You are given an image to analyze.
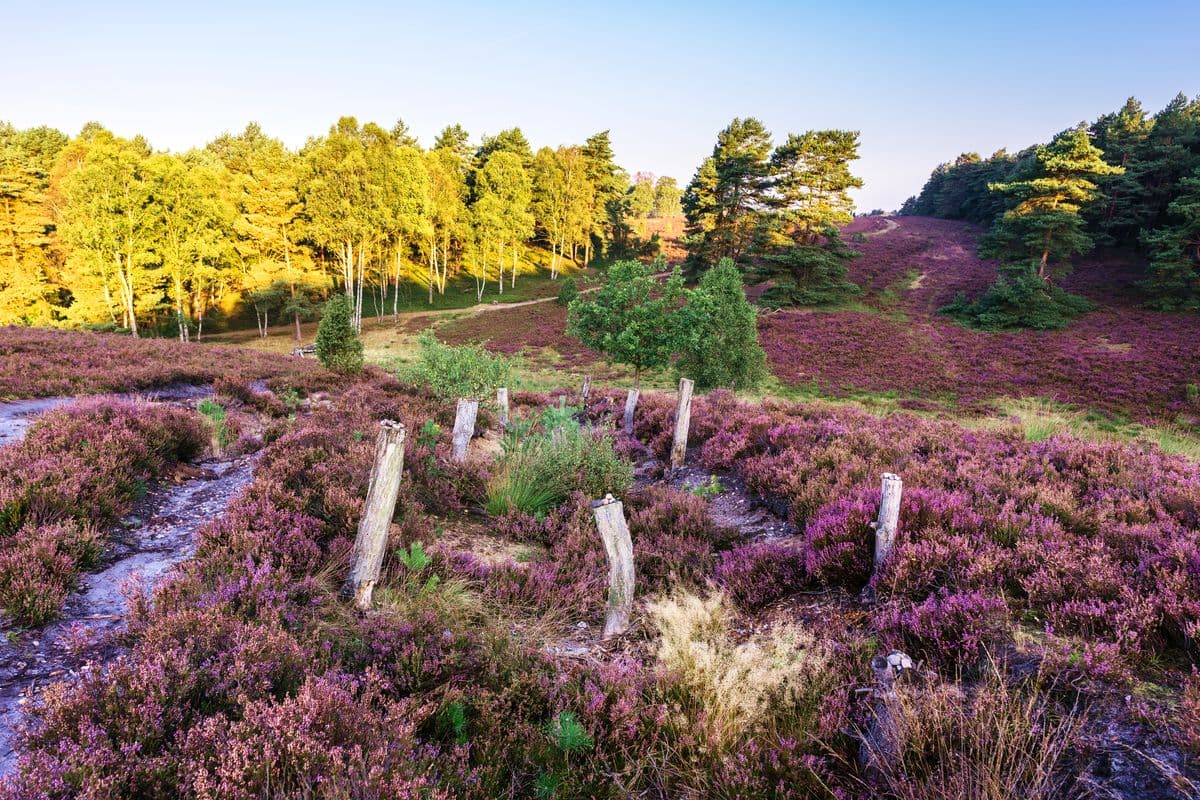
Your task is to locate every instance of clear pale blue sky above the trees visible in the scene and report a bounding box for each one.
[0,0,1200,210]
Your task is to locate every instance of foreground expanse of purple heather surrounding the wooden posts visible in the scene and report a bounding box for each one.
[0,331,1200,800]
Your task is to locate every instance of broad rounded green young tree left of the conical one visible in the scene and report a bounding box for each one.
[566,261,684,380]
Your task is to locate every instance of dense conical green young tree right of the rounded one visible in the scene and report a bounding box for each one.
[676,258,767,389]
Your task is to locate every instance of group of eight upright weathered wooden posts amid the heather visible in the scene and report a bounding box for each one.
[342,378,904,638]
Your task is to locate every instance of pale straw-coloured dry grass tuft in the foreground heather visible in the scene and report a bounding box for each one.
[646,593,829,756]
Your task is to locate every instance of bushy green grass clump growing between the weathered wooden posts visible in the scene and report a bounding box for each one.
[487,409,634,516]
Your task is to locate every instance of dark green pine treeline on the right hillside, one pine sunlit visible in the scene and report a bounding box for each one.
[900,94,1200,326]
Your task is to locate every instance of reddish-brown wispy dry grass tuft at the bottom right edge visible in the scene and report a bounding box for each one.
[864,663,1084,800]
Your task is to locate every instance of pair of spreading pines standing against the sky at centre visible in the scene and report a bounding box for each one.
[683,118,863,306]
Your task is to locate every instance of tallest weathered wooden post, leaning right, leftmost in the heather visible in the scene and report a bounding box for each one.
[342,420,406,610]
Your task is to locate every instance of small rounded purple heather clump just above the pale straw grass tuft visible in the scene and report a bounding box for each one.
[716,540,805,610]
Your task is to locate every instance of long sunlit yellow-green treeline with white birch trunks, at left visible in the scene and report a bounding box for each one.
[0,118,680,341]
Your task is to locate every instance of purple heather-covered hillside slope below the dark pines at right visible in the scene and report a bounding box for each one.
[761,217,1200,421]
